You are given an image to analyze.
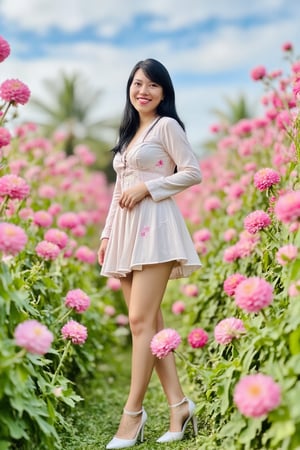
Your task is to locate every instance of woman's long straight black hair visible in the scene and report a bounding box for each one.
[112,58,185,153]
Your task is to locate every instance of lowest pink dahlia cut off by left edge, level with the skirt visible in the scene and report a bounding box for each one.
[0,222,28,255]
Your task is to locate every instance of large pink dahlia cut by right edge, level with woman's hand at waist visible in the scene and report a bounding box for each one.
[274,190,300,223]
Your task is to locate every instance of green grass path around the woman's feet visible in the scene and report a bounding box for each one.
[57,351,206,450]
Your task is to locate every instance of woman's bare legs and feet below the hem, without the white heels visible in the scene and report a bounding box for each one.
[117,264,188,439]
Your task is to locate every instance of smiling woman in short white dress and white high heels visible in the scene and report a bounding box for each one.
[98,59,201,449]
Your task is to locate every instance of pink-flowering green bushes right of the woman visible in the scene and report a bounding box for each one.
[169,44,300,450]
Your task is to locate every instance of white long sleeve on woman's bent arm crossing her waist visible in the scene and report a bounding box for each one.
[145,118,201,202]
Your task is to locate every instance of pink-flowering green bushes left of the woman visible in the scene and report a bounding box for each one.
[0,37,123,450]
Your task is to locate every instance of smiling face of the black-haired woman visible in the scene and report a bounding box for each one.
[129,69,163,118]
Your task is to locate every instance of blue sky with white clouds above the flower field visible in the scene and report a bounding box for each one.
[0,0,300,147]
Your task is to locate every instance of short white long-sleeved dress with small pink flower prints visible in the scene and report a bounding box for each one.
[101,117,201,278]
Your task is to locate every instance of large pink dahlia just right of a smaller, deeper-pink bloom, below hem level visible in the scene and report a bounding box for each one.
[235,277,273,312]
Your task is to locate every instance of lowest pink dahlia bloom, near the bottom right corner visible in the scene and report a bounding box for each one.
[233,373,281,417]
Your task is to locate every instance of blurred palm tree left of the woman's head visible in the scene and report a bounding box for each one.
[30,73,117,165]
